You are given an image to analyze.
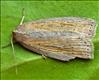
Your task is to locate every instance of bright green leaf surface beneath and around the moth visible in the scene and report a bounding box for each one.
[1,1,99,80]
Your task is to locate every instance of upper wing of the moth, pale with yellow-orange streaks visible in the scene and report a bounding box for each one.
[17,17,96,38]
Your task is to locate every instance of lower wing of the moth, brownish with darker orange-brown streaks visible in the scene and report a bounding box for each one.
[14,32,93,61]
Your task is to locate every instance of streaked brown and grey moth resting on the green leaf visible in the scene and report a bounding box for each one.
[13,17,96,61]
